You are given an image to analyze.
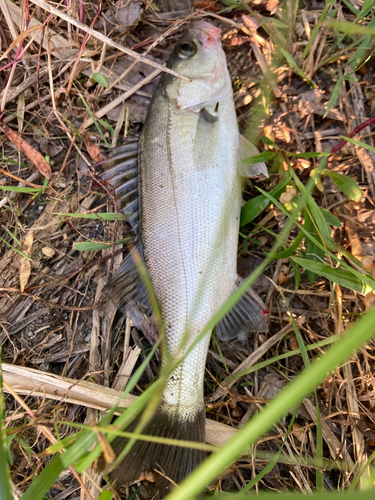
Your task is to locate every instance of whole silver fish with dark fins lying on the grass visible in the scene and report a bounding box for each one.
[98,21,268,498]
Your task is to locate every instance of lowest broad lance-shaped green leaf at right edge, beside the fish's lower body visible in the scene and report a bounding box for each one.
[291,257,375,294]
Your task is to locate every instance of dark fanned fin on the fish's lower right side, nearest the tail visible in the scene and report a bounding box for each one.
[216,278,268,340]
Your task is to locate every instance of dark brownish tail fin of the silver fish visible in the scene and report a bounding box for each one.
[110,407,205,498]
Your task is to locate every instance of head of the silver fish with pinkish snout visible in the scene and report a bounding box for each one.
[166,21,232,111]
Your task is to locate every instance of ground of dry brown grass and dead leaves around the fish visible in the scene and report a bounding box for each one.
[0,0,375,500]
